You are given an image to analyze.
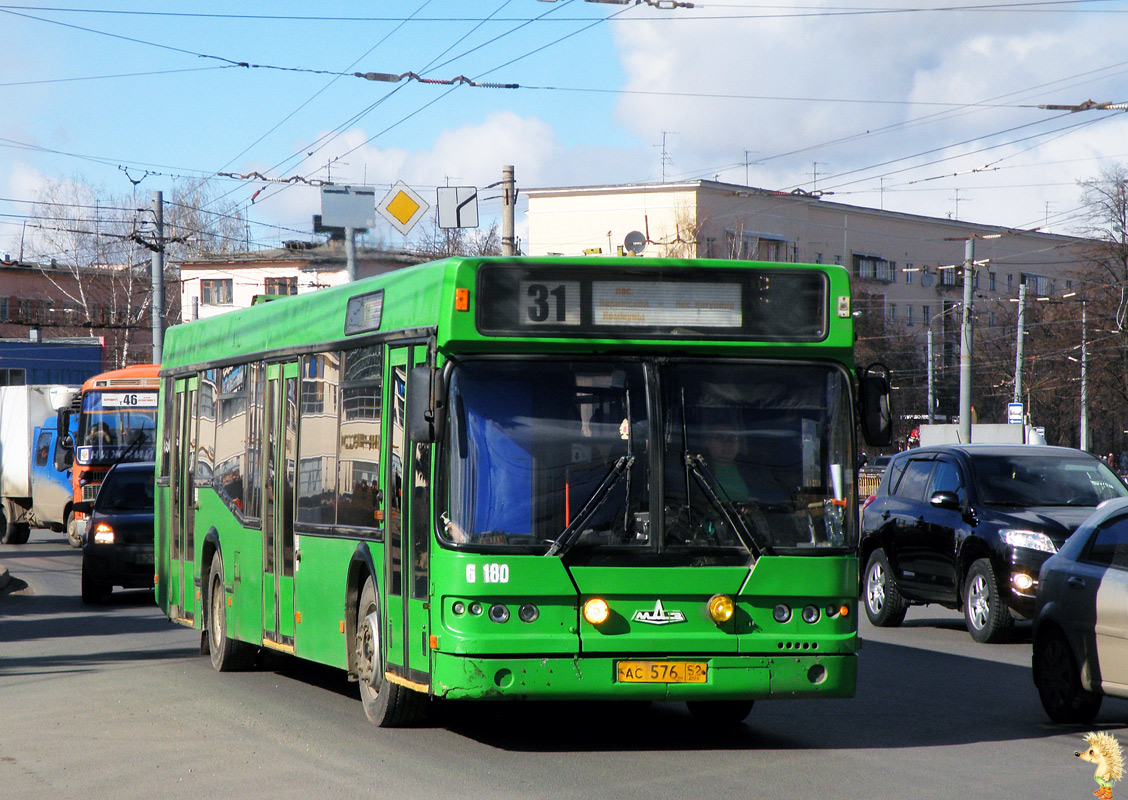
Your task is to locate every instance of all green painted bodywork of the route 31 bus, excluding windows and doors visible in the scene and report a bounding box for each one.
[156,257,857,700]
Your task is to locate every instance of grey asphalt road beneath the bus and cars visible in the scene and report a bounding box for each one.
[0,530,1128,800]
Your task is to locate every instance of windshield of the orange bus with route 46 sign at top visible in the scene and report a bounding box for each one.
[76,390,157,464]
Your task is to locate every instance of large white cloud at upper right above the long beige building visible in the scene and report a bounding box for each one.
[616,3,1128,232]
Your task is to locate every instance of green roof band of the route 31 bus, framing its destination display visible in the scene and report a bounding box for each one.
[161,256,854,375]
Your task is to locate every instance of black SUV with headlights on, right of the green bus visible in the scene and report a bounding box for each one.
[858,445,1128,642]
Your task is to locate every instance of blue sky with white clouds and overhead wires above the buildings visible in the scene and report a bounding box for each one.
[0,0,1128,256]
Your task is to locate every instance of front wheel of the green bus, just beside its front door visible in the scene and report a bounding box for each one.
[353,578,426,728]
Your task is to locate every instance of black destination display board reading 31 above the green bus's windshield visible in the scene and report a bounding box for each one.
[477,265,828,342]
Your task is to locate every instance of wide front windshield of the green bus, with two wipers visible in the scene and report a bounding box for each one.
[440,359,856,557]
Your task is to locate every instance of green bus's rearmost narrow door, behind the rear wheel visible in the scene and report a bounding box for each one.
[169,376,199,622]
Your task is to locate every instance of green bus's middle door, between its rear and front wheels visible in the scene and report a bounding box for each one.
[263,362,298,652]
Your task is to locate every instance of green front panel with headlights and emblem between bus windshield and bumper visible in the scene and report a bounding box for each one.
[432,554,857,657]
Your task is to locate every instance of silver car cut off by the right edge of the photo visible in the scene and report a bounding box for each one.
[1032,498,1128,723]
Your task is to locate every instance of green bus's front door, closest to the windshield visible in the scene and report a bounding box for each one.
[381,345,431,688]
